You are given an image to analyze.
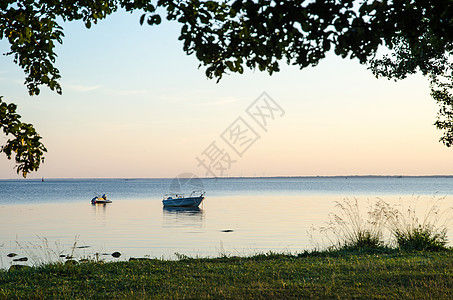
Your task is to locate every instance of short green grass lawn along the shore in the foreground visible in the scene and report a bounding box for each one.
[0,250,453,299]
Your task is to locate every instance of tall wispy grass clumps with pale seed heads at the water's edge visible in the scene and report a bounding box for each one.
[320,197,453,251]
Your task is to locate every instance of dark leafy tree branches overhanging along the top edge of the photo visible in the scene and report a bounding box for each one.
[0,0,453,176]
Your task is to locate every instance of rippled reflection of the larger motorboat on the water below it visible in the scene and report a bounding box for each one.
[162,207,204,229]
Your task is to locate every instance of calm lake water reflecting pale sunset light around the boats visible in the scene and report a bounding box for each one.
[0,177,453,267]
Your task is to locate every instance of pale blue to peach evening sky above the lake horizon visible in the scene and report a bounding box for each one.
[0,12,453,179]
